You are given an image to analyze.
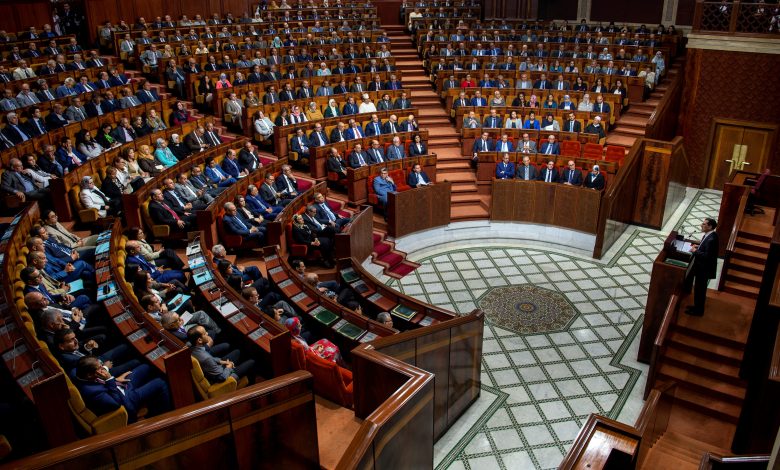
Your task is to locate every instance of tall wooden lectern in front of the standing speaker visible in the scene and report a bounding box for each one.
[637,231,693,364]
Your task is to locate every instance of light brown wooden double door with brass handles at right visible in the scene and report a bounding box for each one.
[707,120,777,189]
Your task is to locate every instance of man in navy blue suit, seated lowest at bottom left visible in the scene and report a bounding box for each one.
[74,356,171,423]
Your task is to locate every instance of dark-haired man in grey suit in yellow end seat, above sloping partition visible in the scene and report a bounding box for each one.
[187,325,255,384]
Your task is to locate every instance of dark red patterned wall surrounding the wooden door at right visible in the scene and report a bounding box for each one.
[680,49,780,186]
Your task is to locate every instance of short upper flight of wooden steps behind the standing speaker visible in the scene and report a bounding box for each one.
[723,230,771,299]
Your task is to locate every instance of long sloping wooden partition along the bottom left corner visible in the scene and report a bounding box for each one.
[2,371,319,470]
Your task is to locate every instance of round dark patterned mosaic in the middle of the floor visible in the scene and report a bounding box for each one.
[478,284,577,334]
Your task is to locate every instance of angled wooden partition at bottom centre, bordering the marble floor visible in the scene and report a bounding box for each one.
[337,310,484,469]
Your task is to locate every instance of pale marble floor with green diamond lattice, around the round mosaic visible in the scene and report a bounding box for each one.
[366,189,720,470]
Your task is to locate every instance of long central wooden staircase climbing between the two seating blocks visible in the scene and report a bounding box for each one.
[382,25,490,221]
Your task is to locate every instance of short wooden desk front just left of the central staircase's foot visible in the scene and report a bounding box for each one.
[386,181,452,237]
